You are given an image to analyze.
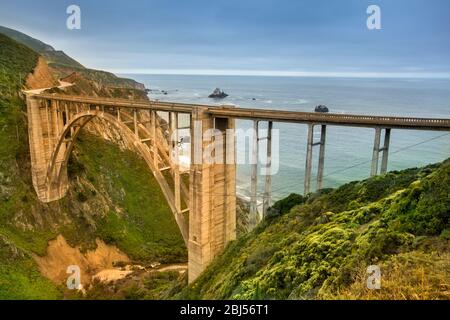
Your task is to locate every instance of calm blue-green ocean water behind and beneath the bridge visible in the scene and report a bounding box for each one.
[123,74,450,200]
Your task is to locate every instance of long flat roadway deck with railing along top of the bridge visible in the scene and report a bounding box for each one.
[32,94,450,131]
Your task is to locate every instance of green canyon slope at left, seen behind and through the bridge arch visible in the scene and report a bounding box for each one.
[0,34,187,299]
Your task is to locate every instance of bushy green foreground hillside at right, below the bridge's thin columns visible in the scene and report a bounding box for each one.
[181,159,450,299]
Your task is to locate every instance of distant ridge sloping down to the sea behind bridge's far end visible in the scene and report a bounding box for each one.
[0,26,145,91]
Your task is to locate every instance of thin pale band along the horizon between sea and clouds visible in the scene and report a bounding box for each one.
[109,68,450,79]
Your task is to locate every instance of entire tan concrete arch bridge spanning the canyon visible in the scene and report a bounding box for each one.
[27,93,450,281]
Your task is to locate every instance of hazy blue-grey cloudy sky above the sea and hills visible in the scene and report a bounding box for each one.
[0,0,450,76]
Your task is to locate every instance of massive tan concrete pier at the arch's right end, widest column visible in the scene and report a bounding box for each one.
[188,107,236,282]
